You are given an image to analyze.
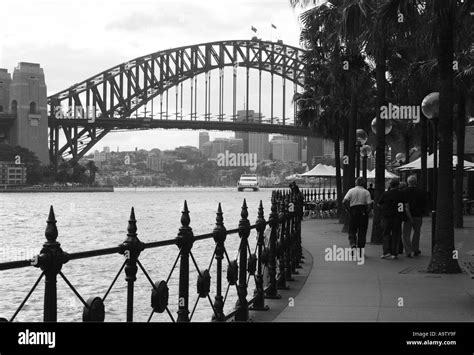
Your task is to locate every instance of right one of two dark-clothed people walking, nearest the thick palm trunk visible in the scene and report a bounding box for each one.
[403,175,428,258]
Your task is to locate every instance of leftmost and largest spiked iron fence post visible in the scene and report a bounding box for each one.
[31,206,69,322]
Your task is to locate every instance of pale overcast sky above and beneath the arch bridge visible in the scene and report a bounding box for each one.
[0,0,310,151]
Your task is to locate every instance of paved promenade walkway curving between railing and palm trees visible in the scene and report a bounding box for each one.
[269,216,474,322]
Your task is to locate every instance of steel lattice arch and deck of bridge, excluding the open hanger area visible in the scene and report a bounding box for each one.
[48,40,311,163]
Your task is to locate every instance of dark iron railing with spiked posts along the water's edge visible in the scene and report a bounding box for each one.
[0,191,303,322]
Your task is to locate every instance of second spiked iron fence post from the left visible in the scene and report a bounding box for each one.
[119,207,144,322]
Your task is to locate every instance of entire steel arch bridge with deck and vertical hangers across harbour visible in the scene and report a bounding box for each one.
[4,38,312,164]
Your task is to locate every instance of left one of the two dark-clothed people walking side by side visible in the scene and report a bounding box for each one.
[378,179,411,259]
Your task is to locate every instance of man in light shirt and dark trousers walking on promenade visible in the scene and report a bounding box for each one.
[343,177,372,251]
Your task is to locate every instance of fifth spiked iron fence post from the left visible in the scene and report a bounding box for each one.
[235,199,250,322]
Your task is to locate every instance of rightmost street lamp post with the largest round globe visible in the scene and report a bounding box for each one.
[421,92,439,253]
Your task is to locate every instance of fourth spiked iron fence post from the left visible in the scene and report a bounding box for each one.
[213,203,227,322]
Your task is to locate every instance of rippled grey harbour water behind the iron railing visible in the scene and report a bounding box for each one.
[0,188,271,322]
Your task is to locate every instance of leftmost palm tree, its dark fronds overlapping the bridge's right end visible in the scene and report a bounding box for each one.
[290,1,348,221]
